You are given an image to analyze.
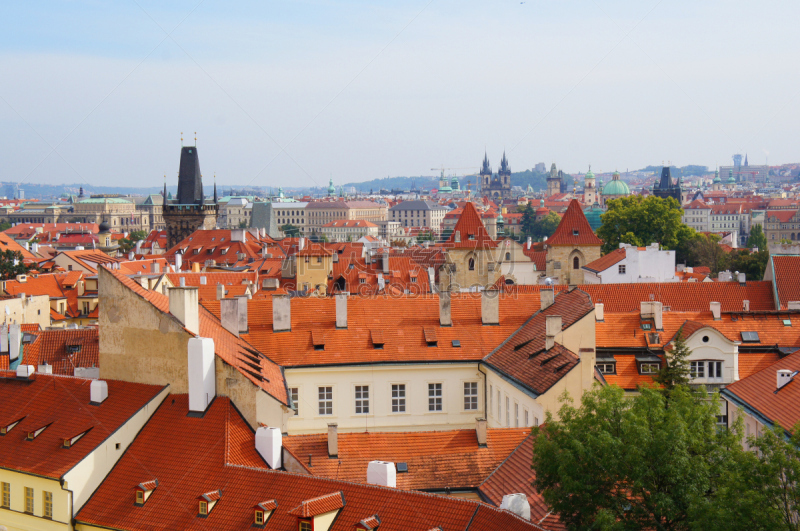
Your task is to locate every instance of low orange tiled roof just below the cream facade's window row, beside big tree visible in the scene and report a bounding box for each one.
[283,428,530,494]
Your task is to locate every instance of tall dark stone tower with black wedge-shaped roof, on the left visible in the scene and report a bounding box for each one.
[164,146,219,249]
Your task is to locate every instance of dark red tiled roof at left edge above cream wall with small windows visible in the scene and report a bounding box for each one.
[0,372,163,478]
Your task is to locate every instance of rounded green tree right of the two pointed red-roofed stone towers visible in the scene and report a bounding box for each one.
[597,195,695,254]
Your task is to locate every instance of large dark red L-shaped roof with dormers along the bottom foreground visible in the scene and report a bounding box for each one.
[76,395,552,531]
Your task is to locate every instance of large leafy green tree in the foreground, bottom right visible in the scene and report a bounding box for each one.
[533,385,742,531]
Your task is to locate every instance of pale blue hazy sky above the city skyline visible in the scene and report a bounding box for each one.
[0,0,800,191]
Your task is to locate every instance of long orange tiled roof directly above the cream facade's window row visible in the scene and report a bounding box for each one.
[203,294,540,366]
